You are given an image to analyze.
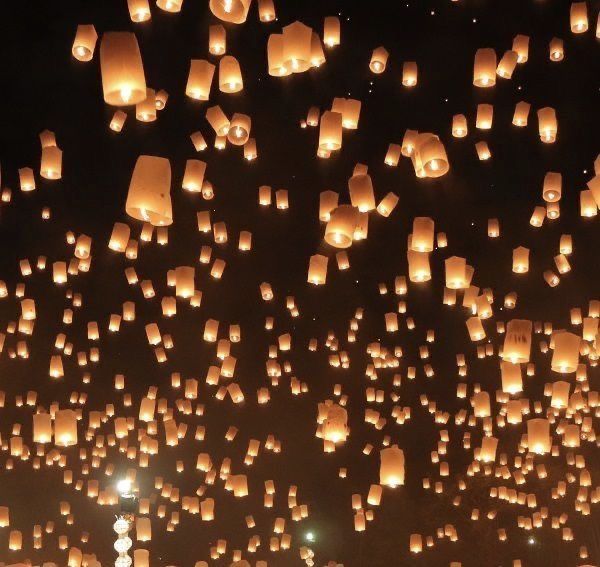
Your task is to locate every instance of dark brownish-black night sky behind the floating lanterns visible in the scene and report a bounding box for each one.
[0,0,600,567]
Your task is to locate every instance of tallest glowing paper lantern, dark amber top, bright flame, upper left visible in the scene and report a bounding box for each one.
[100,32,146,106]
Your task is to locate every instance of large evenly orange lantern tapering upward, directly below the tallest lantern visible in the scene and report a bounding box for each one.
[125,155,173,226]
